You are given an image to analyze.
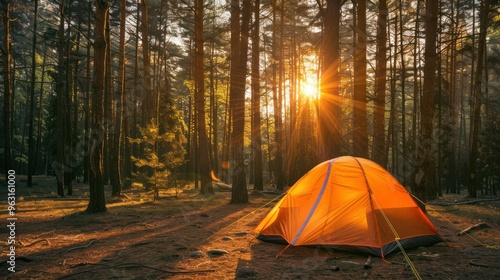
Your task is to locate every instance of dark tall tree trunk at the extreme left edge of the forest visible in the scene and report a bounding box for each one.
[2,0,14,181]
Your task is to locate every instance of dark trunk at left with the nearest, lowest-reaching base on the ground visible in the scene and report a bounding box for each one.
[86,0,109,213]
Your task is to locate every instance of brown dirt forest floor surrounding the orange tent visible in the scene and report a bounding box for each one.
[0,177,500,279]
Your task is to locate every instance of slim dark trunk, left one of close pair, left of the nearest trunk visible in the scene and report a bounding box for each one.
[52,0,66,197]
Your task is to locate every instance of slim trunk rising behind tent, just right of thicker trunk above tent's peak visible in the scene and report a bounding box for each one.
[372,0,387,167]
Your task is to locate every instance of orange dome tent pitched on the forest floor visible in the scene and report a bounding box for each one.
[254,156,442,256]
